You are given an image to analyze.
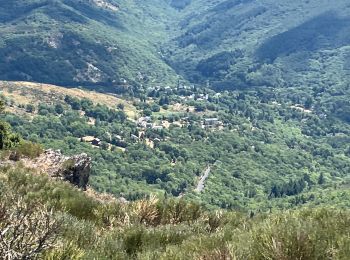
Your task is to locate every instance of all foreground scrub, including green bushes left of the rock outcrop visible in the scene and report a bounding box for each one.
[0,101,350,259]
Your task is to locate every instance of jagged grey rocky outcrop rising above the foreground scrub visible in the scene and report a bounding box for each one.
[21,149,91,190]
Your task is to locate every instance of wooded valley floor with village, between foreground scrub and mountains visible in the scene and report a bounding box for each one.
[2,79,350,212]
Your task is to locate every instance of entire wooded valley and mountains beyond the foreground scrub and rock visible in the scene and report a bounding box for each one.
[0,0,350,210]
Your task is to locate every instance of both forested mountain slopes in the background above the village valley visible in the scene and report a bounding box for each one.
[0,0,350,92]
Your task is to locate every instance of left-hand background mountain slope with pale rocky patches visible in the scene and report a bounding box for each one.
[0,0,179,91]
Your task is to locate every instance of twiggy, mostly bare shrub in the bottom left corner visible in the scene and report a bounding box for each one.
[0,193,61,259]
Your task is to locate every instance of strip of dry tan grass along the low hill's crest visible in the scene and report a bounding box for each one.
[0,81,138,119]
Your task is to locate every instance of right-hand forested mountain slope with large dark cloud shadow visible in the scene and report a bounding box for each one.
[166,0,350,89]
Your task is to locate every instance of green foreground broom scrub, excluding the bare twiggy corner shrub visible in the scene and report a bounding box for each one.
[0,168,350,260]
